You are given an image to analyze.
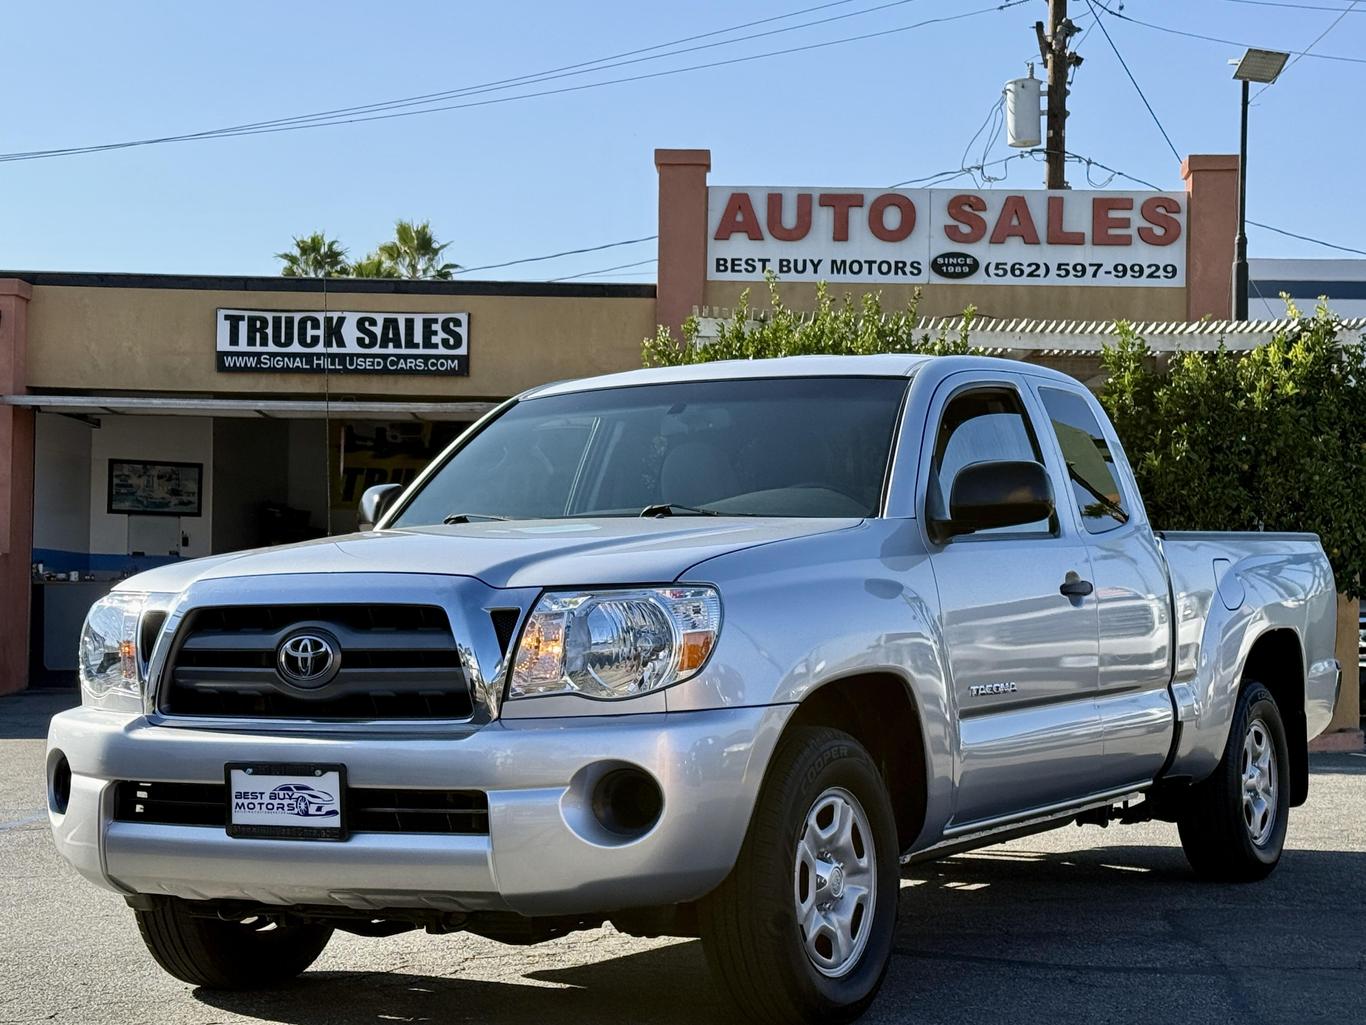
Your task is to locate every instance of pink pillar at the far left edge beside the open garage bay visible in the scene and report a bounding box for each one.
[0,277,33,694]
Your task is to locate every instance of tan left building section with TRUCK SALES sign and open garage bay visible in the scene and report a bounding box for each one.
[0,273,654,692]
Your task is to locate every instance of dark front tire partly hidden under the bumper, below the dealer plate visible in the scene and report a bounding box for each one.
[135,901,332,989]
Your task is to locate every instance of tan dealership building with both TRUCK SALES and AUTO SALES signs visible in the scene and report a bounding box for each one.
[0,150,1366,743]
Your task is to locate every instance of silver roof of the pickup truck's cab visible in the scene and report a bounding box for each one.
[523,353,1075,398]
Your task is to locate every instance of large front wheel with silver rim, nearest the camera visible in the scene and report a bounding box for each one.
[698,727,900,1025]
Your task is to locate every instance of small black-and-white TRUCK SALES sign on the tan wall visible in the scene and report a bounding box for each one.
[217,310,470,376]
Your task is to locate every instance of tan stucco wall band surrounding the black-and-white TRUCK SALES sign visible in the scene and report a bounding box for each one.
[27,283,654,399]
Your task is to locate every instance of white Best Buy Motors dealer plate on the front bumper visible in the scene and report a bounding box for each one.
[224,761,346,841]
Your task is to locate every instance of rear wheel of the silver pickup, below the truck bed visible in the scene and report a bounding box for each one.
[1176,679,1291,883]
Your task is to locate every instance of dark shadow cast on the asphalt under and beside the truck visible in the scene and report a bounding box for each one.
[195,827,1366,1025]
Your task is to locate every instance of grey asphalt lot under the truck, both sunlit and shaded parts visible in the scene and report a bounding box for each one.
[0,693,1366,1025]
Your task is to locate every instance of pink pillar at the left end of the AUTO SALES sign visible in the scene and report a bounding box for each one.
[654,149,712,339]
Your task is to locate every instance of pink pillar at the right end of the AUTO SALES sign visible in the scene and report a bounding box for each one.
[1182,154,1238,320]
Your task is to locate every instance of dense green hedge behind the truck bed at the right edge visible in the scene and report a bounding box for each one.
[1101,306,1366,597]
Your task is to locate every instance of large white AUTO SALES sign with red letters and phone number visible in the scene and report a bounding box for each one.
[706,186,1186,287]
